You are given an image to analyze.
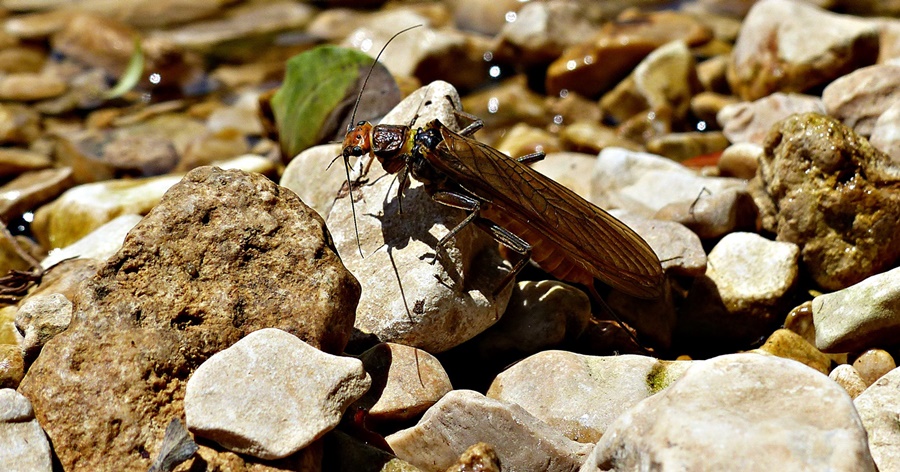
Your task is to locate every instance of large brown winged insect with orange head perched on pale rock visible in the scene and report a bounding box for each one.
[342,112,664,298]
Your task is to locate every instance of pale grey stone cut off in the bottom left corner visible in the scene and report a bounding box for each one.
[0,388,53,472]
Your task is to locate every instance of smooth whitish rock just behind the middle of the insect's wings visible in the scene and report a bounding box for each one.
[590,148,746,218]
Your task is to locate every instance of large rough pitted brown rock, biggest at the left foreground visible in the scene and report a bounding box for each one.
[20,168,359,470]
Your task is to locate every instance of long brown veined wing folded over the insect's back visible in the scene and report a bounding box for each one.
[426,123,663,298]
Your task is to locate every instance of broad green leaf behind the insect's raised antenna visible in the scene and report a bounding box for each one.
[270,46,399,160]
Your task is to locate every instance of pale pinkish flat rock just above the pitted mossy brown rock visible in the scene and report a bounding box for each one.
[716,92,825,146]
